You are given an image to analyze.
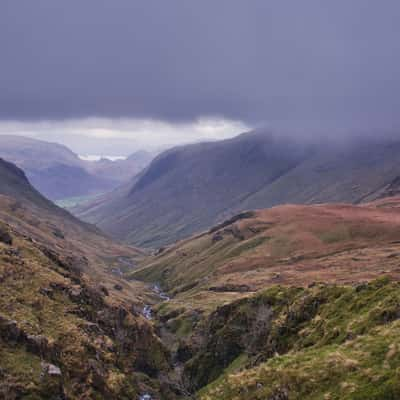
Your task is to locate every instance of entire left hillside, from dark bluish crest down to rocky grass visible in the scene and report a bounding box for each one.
[0,160,181,400]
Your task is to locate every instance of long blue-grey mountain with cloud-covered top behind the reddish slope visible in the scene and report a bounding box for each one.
[75,132,400,247]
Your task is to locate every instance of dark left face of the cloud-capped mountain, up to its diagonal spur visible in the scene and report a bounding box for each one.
[78,134,309,247]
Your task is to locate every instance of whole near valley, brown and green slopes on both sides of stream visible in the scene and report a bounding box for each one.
[0,134,400,400]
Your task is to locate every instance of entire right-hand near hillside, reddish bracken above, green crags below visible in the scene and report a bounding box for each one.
[128,197,400,400]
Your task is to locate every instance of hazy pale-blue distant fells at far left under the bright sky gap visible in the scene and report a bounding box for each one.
[0,135,151,200]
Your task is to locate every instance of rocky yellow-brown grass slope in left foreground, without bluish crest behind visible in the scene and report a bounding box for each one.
[0,217,170,400]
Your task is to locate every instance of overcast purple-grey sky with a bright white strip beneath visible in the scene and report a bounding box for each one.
[0,0,400,154]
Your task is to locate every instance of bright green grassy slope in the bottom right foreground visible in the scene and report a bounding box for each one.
[199,280,400,400]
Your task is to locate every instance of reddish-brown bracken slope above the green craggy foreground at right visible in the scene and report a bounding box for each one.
[132,197,400,310]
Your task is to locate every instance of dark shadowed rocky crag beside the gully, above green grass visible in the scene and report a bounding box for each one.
[179,291,326,392]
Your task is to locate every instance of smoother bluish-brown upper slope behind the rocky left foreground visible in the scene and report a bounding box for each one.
[0,159,148,290]
